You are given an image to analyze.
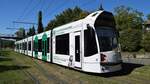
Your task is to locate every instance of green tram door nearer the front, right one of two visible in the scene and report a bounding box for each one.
[42,34,48,61]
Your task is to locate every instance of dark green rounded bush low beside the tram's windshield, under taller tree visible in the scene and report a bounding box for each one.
[120,29,142,52]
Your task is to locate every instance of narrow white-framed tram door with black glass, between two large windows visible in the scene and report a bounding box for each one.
[75,32,81,68]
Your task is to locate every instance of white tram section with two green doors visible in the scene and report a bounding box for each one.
[33,31,51,62]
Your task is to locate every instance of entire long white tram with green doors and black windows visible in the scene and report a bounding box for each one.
[15,11,122,73]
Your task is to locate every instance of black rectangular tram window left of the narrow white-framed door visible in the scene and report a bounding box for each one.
[56,34,69,55]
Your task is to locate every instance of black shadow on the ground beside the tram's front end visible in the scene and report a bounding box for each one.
[100,63,144,77]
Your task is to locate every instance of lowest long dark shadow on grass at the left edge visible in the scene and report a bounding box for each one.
[0,65,30,73]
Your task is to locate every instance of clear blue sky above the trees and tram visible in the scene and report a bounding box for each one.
[0,0,150,34]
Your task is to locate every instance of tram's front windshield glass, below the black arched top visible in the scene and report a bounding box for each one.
[96,27,118,52]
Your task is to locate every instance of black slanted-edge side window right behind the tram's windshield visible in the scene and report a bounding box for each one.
[84,30,98,57]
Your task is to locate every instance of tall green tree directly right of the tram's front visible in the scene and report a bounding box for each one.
[114,6,143,51]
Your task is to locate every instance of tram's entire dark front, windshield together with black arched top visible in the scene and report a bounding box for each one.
[94,11,119,52]
